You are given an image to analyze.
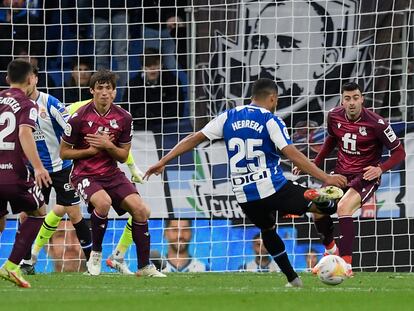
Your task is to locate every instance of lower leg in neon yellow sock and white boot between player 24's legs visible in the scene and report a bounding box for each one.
[106,217,134,274]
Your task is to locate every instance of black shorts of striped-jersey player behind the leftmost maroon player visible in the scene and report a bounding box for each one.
[42,166,80,206]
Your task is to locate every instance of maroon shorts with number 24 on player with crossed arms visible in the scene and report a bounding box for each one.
[71,171,138,215]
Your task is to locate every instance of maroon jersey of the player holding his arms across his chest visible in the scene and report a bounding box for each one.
[62,102,132,178]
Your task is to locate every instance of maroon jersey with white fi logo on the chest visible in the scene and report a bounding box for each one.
[328,107,400,174]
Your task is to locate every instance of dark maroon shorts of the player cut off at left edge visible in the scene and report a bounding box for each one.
[0,179,45,216]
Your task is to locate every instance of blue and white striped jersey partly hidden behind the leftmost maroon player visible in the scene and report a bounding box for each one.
[34,92,72,173]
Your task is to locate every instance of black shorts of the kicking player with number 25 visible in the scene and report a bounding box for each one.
[239,180,312,229]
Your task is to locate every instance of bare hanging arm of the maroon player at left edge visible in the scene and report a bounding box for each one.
[19,125,52,188]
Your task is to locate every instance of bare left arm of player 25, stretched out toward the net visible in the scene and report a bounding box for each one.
[144,132,207,180]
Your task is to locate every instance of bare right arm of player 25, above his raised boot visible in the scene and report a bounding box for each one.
[282,145,347,188]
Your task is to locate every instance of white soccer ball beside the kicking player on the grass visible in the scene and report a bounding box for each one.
[316,255,346,285]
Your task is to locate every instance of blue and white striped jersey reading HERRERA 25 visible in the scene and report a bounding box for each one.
[201,104,292,203]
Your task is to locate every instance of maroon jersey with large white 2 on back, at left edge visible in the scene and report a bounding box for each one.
[0,88,37,184]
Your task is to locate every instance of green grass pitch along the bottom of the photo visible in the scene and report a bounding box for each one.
[0,273,414,311]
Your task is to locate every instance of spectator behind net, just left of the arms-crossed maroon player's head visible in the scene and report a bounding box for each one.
[63,58,92,103]
